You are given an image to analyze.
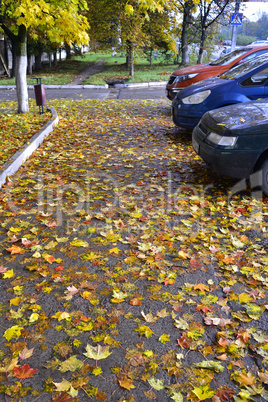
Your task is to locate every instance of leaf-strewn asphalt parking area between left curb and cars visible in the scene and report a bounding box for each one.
[0,100,268,402]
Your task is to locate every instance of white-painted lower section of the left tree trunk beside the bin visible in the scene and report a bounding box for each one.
[15,55,29,113]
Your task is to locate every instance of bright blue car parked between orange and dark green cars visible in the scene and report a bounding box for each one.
[172,54,268,130]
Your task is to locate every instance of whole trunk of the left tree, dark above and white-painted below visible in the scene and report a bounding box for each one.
[15,25,29,113]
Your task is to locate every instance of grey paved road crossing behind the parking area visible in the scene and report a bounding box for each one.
[0,85,166,101]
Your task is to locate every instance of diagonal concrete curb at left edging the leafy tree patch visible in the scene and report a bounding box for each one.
[0,107,59,188]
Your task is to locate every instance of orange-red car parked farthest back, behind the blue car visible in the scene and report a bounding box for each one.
[166,44,268,100]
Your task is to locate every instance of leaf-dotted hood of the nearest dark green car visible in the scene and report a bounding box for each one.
[203,99,268,135]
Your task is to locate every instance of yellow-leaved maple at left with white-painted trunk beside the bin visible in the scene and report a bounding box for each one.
[0,0,88,113]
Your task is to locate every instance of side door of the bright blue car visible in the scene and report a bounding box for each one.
[239,67,268,100]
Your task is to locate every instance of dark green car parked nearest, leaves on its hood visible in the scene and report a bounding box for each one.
[192,99,268,196]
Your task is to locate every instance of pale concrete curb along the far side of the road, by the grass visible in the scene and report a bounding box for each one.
[0,81,167,90]
